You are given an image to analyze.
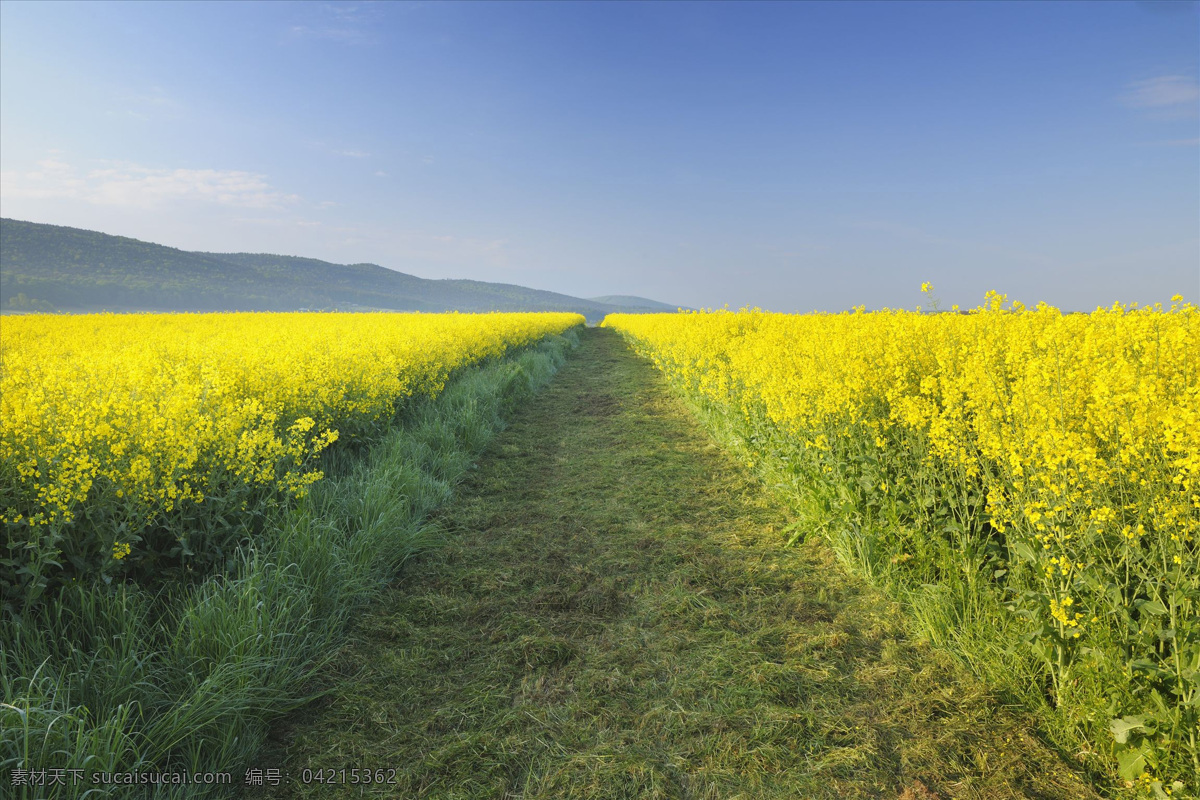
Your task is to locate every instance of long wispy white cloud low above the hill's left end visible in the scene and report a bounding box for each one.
[0,158,300,209]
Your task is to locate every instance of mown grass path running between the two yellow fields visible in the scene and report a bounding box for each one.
[254,330,1093,800]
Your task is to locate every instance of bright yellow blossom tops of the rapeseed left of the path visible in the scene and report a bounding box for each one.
[0,313,583,532]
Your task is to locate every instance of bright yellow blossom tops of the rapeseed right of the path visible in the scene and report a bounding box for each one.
[604,295,1200,573]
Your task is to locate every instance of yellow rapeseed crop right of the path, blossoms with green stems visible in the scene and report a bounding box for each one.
[604,296,1200,788]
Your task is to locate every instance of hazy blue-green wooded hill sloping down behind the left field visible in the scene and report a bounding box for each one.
[0,219,674,321]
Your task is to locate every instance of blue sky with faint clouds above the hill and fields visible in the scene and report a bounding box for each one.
[0,0,1200,311]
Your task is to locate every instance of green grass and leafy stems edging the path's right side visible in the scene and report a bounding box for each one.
[657,384,1180,799]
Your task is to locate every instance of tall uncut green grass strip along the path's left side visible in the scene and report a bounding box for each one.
[0,333,577,799]
